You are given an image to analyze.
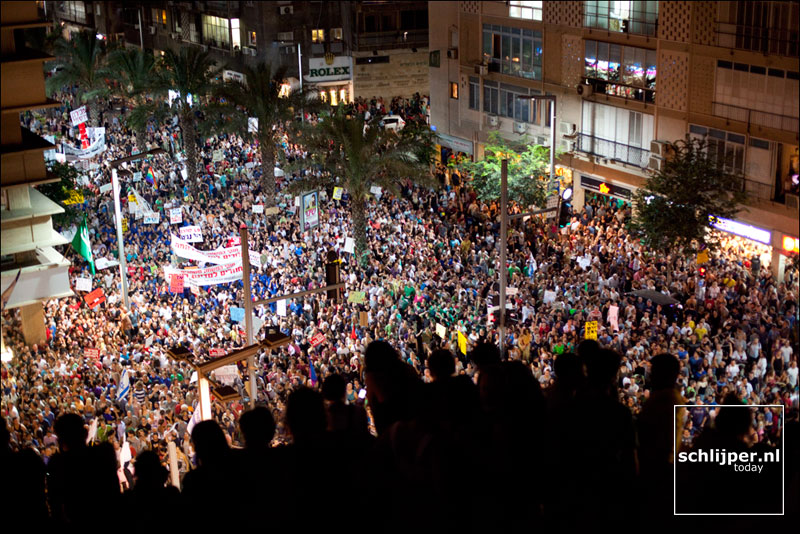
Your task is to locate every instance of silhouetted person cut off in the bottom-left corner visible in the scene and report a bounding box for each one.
[0,419,47,528]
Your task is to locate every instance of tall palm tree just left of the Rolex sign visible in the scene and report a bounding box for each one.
[220,63,312,207]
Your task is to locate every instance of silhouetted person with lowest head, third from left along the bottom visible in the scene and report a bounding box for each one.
[123,451,180,532]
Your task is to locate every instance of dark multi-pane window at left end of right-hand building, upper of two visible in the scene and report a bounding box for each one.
[483,24,542,80]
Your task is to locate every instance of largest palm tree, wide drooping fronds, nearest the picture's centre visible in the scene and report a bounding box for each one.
[290,107,436,267]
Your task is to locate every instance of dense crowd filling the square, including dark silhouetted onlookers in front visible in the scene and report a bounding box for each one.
[2,87,799,530]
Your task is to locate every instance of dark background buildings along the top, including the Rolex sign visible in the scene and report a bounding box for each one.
[50,1,428,105]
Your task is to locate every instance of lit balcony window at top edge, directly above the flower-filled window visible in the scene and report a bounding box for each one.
[583,0,658,35]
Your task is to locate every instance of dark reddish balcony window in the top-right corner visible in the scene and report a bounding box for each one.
[717,1,800,57]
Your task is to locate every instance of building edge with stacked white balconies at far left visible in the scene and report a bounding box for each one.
[0,2,73,344]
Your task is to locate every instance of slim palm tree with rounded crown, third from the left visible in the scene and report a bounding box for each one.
[154,47,219,194]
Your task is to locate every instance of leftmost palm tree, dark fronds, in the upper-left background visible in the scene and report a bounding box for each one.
[46,30,109,126]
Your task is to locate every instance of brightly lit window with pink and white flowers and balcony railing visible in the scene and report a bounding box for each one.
[584,40,656,103]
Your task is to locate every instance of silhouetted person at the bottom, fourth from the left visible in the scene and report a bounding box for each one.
[181,421,239,529]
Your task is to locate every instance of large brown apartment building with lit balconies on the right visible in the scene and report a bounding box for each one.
[428,0,800,276]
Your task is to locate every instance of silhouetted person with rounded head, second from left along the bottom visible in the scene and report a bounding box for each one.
[47,414,120,526]
